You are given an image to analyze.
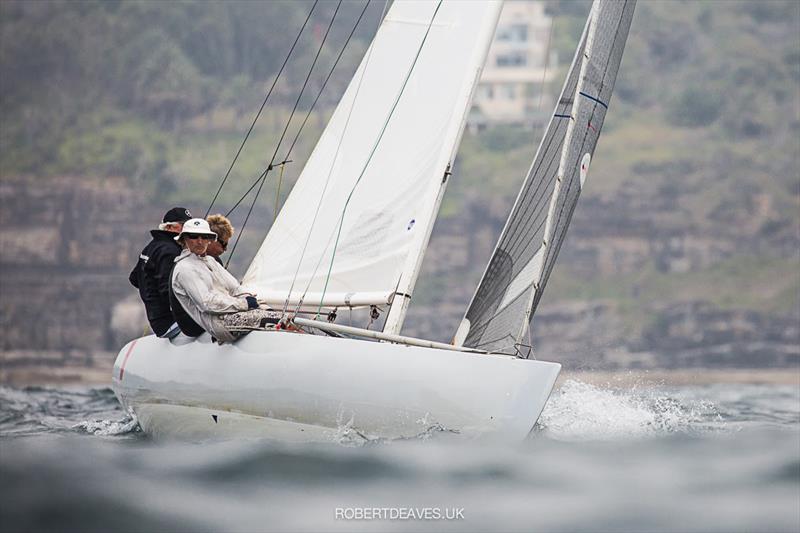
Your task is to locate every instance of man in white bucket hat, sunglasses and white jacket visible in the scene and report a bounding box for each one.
[172,218,278,342]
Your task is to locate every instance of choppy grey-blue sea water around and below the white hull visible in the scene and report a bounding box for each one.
[0,381,800,531]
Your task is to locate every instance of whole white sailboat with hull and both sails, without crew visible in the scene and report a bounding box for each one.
[112,0,634,441]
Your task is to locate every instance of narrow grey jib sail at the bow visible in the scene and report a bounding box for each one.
[455,0,635,353]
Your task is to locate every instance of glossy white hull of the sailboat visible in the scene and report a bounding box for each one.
[113,331,561,441]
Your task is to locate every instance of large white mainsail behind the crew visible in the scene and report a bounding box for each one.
[244,0,500,329]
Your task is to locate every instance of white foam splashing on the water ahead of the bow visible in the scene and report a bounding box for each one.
[538,380,722,440]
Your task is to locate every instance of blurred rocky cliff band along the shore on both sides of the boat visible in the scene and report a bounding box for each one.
[0,177,800,374]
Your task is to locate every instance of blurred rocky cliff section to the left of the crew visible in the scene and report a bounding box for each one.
[0,177,151,374]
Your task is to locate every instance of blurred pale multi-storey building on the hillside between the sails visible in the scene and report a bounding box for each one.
[467,0,558,131]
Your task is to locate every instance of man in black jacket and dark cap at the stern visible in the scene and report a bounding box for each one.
[128,207,192,337]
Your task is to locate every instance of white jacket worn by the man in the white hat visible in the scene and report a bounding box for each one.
[172,249,249,342]
